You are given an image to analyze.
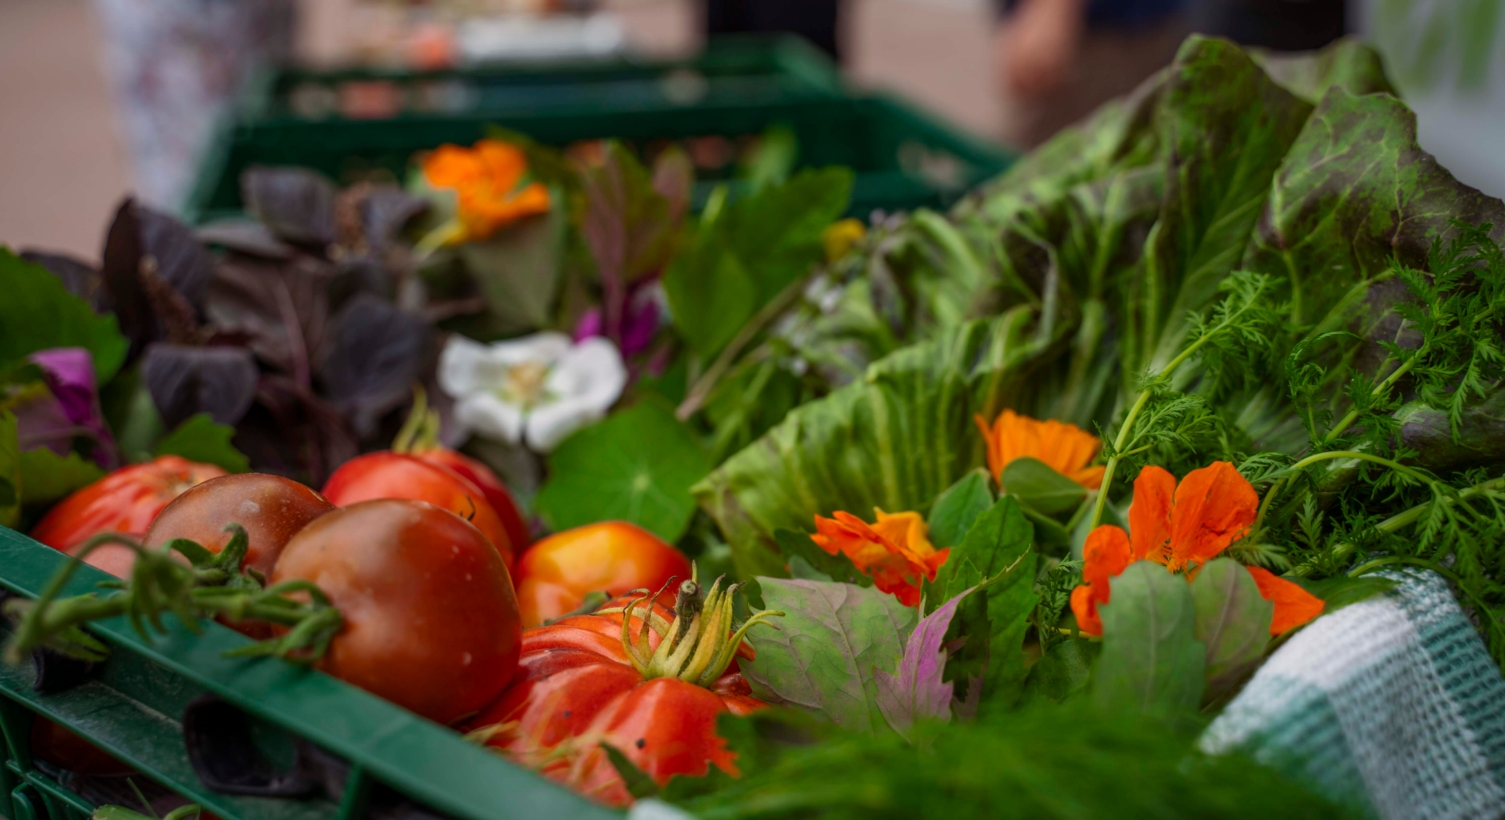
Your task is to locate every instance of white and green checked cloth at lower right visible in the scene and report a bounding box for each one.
[1201,572,1505,820]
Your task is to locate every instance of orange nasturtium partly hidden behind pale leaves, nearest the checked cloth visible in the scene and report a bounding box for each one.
[1072,462,1323,635]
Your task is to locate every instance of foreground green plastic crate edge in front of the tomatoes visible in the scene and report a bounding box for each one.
[0,527,620,820]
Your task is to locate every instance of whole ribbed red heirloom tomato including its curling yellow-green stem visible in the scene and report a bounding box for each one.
[467,568,781,805]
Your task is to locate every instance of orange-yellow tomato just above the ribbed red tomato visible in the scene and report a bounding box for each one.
[515,521,689,629]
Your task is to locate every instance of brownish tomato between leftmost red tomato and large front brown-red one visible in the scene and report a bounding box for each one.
[141,472,334,575]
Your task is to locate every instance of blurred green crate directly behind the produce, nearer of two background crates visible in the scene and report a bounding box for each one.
[184,95,1011,221]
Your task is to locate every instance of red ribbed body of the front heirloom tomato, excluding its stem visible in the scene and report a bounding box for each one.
[467,589,765,805]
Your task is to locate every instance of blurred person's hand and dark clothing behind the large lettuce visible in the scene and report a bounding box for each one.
[993,0,1192,149]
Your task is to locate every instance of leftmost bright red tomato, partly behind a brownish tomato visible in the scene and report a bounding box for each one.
[32,456,224,556]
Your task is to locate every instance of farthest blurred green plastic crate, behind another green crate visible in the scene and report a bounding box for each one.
[238,38,846,125]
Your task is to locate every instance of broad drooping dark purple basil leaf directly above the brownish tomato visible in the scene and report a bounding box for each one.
[141,343,259,427]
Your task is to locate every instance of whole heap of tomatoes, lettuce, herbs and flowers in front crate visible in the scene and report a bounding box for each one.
[0,38,1505,818]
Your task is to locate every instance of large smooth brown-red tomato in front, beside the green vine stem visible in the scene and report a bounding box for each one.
[269,500,522,724]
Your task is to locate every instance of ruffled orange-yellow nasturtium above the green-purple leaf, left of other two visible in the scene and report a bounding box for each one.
[810,509,951,606]
